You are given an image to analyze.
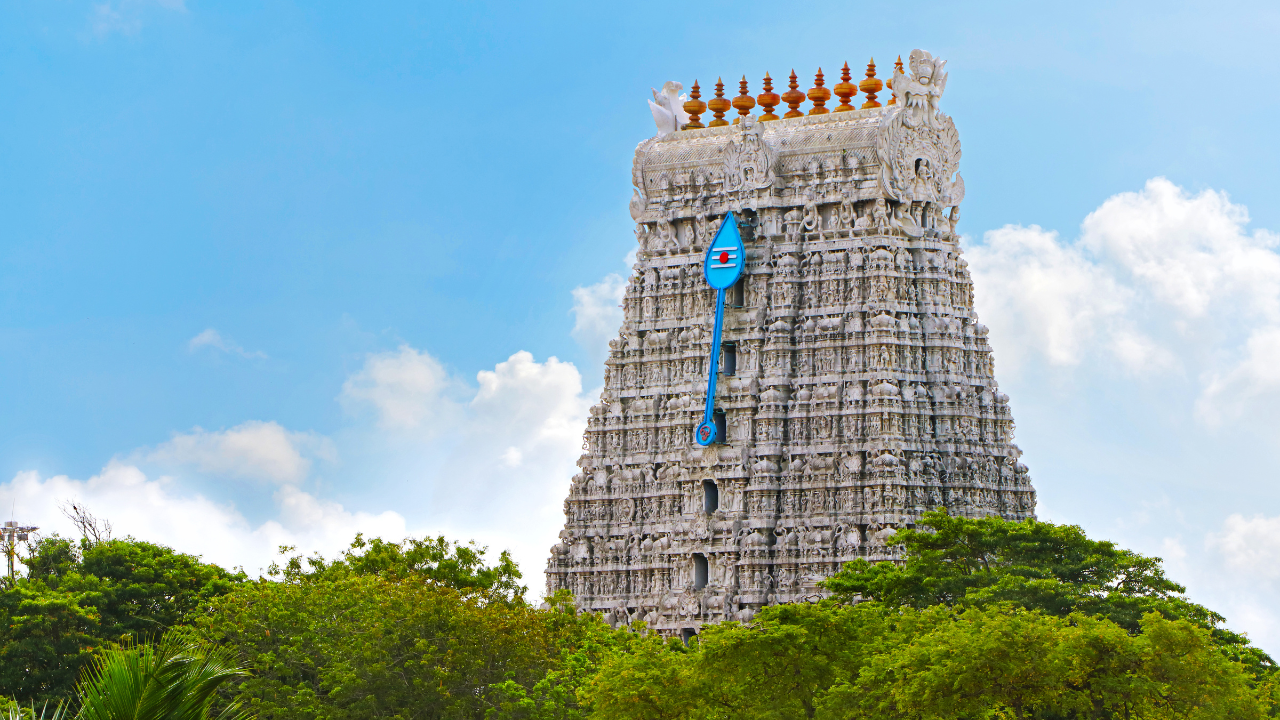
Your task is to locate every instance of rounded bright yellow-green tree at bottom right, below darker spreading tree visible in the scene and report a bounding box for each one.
[818,607,1267,720]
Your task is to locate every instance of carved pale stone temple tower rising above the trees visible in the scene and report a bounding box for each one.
[547,50,1036,635]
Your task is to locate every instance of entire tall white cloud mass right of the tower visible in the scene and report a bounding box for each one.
[965,178,1280,651]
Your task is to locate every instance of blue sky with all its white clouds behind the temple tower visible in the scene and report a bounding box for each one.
[0,0,1280,651]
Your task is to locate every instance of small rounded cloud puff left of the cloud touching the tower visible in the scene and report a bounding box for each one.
[340,345,456,430]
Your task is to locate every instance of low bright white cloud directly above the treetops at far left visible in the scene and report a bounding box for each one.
[0,461,407,573]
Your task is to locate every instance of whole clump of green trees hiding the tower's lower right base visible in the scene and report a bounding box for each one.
[581,514,1277,720]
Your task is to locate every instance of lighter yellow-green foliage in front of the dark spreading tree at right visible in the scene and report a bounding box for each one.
[584,602,1274,720]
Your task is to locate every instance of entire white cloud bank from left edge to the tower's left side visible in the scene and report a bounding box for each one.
[8,338,590,594]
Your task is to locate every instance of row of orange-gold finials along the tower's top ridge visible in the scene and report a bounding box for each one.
[681,55,902,129]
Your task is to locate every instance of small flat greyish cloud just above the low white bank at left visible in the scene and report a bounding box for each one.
[140,420,337,483]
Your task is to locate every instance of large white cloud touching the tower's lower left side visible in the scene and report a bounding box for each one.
[344,347,598,591]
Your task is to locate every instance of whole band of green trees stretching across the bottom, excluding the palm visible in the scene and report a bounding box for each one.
[0,514,1280,720]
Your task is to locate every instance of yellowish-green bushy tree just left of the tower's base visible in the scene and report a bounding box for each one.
[201,538,608,720]
